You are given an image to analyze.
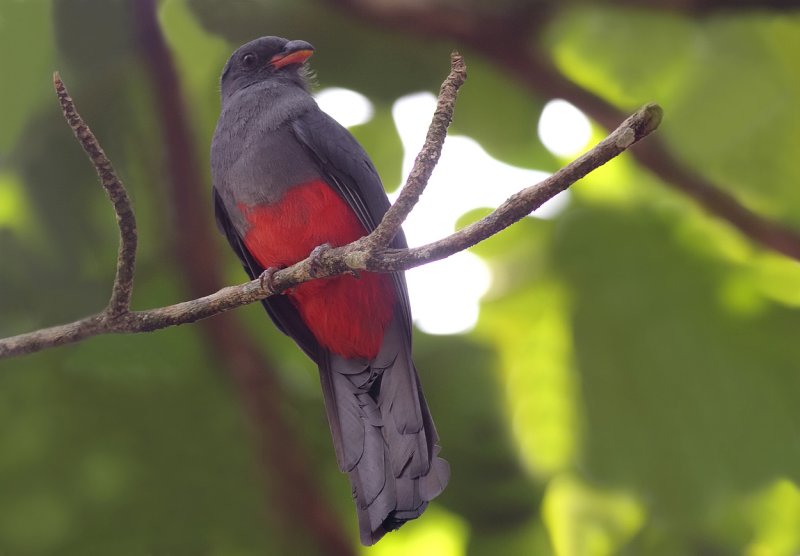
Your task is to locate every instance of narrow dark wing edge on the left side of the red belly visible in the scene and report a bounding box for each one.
[212,188,320,362]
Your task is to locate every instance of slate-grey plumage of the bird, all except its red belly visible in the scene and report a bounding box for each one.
[211,37,450,545]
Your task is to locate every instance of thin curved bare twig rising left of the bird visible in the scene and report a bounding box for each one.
[53,72,137,317]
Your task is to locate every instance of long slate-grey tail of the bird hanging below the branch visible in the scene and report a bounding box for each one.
[320,323,450,546]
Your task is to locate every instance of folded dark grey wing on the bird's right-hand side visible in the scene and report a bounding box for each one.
[291,109,411,336]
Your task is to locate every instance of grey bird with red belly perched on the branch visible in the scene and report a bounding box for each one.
[211,36,450,546]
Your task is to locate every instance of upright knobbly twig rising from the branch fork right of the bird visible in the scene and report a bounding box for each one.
[365,51,467,248]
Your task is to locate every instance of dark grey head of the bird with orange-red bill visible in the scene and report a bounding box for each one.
[221,37,314,99]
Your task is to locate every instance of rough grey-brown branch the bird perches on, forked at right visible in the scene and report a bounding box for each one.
[0,55,662,359]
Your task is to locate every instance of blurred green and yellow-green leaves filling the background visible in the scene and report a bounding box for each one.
[0,0,800,556]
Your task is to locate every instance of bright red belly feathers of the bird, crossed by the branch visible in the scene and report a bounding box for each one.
[239,179,395,359]
